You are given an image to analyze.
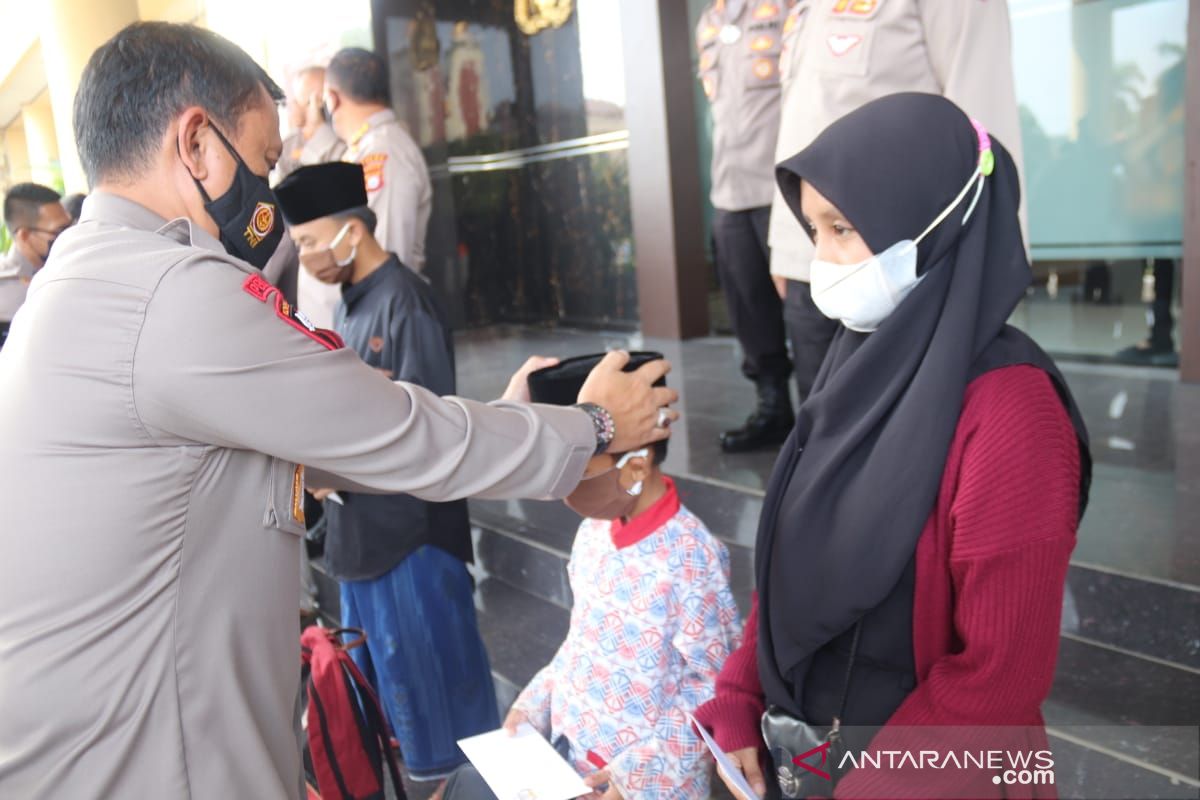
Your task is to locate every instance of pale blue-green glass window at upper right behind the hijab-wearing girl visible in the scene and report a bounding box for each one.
[1009,0,1188,366]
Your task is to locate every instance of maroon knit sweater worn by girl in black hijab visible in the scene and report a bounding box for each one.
[696,366,1080,798]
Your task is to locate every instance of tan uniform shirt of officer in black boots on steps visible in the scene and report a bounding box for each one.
[696,0,787,211]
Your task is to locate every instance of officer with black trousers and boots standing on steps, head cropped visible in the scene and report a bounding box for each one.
[696,0,794,452]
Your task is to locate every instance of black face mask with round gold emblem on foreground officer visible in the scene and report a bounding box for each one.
[192,127,283,269]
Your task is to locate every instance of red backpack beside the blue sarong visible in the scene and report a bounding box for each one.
[300,625,407,800]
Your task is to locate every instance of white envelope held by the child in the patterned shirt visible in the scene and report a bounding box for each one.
[458,723,592,800]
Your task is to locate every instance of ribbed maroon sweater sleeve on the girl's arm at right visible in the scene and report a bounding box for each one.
[838,367,1080,798]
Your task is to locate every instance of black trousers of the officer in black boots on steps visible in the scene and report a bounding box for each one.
[713,206,792,383]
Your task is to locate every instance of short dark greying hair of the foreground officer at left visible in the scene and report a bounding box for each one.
[74,22,283,186]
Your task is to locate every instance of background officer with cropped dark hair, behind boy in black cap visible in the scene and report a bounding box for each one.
[325,47,433,272]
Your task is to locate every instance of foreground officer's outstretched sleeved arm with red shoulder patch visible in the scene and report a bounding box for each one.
[131,257,595,500]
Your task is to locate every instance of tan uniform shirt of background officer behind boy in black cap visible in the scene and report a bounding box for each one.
[346,109,433,272]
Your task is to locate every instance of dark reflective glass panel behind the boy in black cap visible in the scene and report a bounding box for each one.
[374,0,637,327]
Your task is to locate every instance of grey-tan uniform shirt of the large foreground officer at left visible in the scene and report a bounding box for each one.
[0,193,595,800]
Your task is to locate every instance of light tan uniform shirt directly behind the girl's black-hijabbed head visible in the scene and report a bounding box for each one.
[769,0,1024,281]
